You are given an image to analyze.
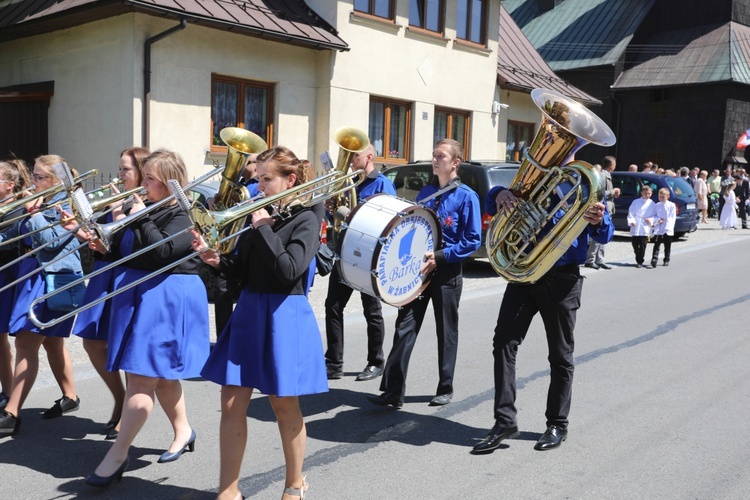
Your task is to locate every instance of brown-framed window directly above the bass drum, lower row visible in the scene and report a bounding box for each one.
[368,98,411,163]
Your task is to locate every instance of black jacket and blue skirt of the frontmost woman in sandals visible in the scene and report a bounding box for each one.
[201,205,328,397]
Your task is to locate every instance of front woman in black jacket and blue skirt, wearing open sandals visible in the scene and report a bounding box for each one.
[193,146,328,500]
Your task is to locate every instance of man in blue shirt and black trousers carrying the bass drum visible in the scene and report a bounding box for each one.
[367,139,482,408]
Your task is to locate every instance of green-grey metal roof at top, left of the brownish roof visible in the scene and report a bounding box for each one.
[504,0,656,71]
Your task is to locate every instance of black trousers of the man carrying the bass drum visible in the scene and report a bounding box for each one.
[380,263,463,396]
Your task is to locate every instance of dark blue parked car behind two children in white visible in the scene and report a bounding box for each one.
[612,171,699,238]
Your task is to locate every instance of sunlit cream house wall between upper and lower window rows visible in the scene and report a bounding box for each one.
[307,0,505,160]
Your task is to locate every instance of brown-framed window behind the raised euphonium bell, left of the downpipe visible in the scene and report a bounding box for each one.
[211,75,273,149]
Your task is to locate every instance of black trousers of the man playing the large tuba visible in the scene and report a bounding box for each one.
[493,266,583,429]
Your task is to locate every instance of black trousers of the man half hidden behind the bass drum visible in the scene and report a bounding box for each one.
[325,266,385,370]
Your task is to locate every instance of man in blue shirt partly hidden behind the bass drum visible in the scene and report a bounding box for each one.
[325,144,396,381]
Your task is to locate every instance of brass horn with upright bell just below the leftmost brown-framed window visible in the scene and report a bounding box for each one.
[213,127,268,253]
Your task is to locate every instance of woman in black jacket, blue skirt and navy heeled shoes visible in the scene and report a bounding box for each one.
[86,149,209,486]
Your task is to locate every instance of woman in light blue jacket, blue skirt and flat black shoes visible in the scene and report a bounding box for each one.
[0,155,83,436]
